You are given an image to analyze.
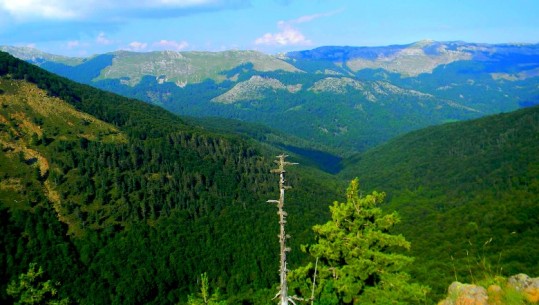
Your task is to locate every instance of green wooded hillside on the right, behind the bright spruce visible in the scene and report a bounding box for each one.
[341,106,539,294]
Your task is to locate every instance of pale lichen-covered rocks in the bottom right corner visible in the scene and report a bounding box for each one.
[438,274,539,305]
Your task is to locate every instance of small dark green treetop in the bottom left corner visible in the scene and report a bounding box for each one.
[7,263,69,305]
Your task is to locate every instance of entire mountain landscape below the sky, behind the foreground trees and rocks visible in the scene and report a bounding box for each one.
[0,42,539,304]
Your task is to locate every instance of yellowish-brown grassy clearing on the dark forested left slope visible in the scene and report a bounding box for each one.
[0,78,127,229]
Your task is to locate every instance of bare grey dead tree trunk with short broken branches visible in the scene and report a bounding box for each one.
[267,154,297,305]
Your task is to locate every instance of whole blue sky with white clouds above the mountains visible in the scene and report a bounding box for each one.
[0,0,539,56]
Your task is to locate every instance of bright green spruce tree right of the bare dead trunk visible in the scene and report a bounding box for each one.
[289,178,429,304]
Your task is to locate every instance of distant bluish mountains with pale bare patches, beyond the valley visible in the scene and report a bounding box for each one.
[3,41,539,156]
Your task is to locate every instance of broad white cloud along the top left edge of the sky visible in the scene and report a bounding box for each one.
[0,0,249,22]
